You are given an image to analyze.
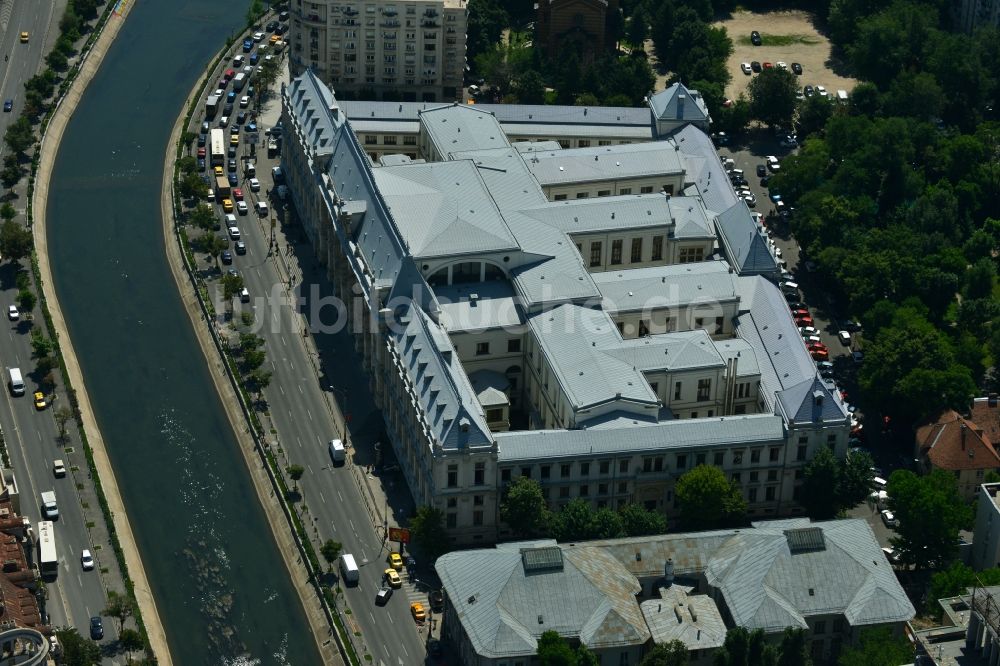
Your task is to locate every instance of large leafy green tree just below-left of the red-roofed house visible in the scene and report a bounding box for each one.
[886,470,972,569]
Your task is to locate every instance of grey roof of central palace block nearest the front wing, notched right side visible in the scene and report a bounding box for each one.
[528,305,658,410]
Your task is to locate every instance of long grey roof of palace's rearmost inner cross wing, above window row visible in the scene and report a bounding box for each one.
[524,141,684,187]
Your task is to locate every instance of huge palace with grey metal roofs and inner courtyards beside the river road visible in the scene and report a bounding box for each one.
[282,71,849,543]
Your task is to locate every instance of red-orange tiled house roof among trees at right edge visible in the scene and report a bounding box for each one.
[917,411,1000,471]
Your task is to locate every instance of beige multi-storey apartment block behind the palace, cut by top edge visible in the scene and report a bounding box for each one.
[288,0,468,102]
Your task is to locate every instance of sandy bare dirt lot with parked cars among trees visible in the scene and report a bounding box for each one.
[715,11,856,99]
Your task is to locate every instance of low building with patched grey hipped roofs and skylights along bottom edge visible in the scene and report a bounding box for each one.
[435,518,915,666]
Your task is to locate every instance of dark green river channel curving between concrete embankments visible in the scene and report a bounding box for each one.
[47,0,320,666]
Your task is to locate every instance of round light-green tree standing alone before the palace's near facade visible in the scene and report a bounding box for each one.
[674,465,747,529]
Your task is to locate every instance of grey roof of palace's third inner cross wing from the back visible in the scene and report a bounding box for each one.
[591,261,739,312]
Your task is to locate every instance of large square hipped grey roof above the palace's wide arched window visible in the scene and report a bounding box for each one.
[373,160,518,258]
